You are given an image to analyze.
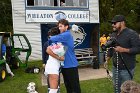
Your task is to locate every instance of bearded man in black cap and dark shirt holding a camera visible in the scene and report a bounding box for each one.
[104,15,140,93]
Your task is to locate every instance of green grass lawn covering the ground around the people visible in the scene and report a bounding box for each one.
[0,55,140,93]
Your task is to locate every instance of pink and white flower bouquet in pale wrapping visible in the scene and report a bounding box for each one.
[50,42,66,66]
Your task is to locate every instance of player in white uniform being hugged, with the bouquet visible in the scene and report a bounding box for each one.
[44,27,65,93]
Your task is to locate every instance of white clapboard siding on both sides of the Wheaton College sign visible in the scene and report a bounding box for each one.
[11,0,99,60]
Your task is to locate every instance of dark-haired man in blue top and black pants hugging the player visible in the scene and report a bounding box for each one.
[47,19,81,93]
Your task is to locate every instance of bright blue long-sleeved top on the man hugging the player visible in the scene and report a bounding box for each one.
[50,30,78,68]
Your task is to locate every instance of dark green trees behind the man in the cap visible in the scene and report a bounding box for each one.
[99,0,140,34]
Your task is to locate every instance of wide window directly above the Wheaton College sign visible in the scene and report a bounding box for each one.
[26,0,89,8]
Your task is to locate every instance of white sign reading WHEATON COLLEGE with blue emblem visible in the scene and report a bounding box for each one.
[26,10,90,23]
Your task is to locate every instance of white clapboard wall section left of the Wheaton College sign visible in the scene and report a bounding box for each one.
[11,0,42,60]
